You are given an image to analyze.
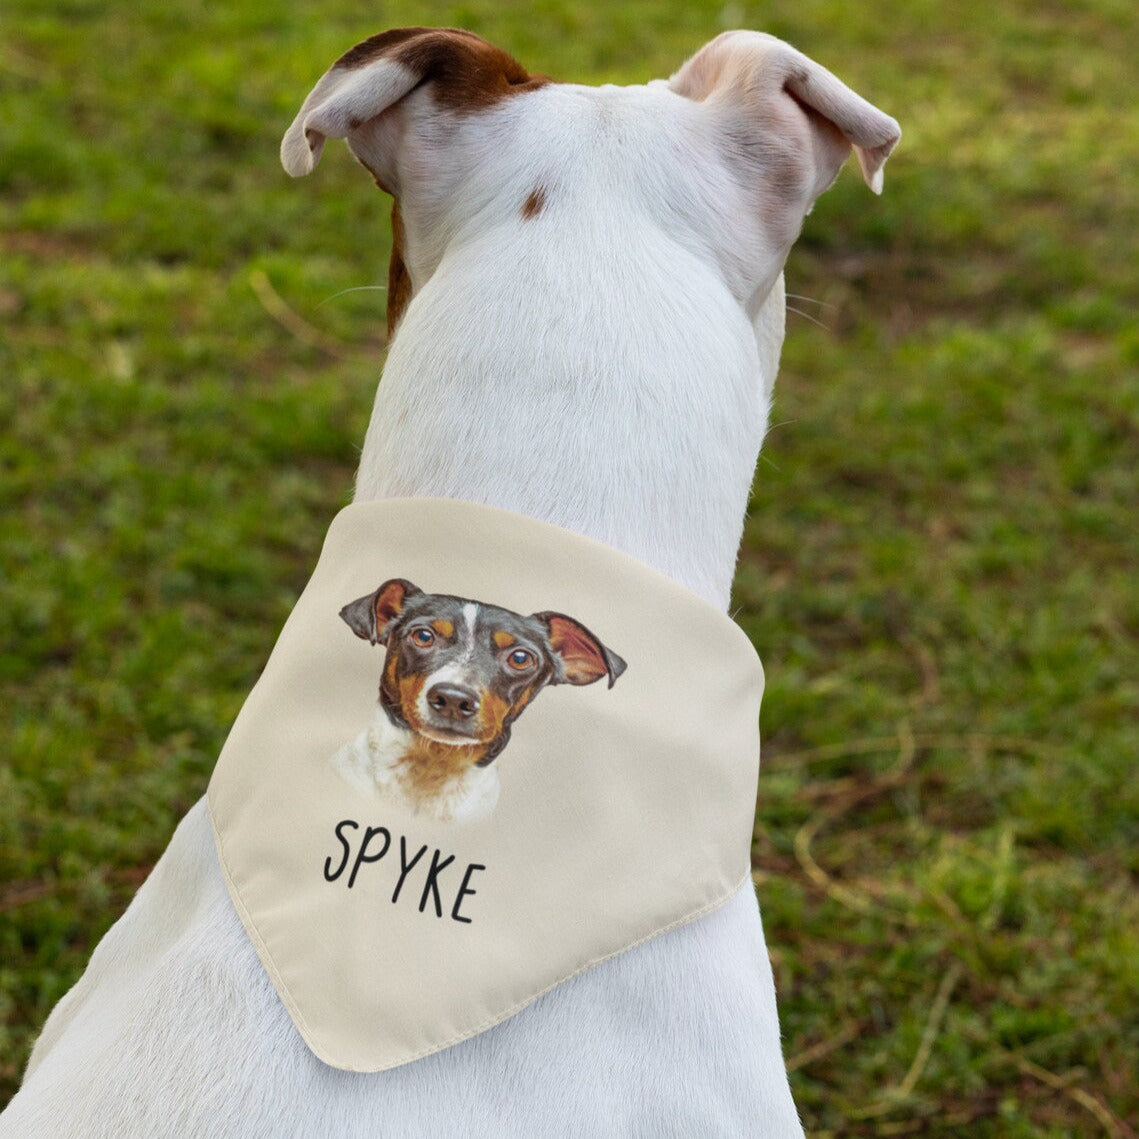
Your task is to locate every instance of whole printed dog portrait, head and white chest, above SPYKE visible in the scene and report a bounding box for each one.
[331,577,625,821]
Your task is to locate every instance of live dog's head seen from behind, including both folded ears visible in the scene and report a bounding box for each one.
[281,27,901,331]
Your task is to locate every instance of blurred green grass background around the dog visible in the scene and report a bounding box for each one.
[0,0,1139,1137]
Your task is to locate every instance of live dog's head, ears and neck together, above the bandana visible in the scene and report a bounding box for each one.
[300,31,899,608]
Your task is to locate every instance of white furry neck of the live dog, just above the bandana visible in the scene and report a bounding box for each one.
[357,241,784,609]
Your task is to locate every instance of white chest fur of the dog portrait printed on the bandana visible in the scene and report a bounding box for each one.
[329,706,499,822]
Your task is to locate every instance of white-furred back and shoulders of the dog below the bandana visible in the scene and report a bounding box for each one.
[0,802,800,1139]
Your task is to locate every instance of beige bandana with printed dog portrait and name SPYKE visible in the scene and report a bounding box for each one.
[208,499,763,1072]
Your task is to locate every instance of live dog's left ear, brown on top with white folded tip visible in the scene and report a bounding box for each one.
[281,27,547,183]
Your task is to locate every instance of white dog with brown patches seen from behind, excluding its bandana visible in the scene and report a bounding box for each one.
[0,28,899,1139]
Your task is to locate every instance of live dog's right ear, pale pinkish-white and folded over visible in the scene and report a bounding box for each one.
[669,32,902,209]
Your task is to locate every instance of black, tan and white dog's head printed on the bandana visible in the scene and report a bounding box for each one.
[341,577,625,764]
